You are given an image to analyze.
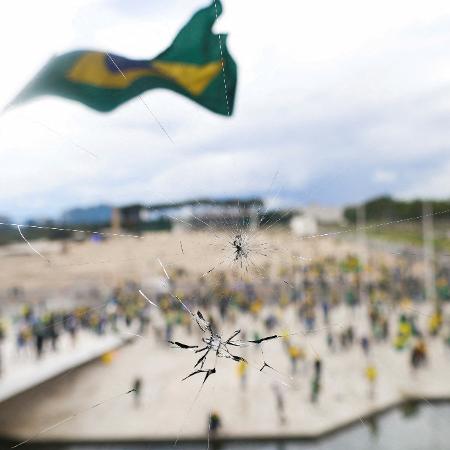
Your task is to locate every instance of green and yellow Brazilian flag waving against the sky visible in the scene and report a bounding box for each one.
[8,0,237,115]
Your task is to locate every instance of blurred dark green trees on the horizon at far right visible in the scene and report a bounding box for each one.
[344,196,450,223]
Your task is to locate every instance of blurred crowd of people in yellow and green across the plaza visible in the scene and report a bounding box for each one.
[0,248,450,429]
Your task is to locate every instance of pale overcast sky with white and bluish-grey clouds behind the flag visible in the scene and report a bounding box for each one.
[0,0,450,220]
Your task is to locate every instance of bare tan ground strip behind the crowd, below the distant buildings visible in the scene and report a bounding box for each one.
[0,229,393,300]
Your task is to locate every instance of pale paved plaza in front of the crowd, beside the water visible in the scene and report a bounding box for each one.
[0,302,450,441]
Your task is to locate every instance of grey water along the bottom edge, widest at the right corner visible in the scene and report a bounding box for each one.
[0,403,450,450]
